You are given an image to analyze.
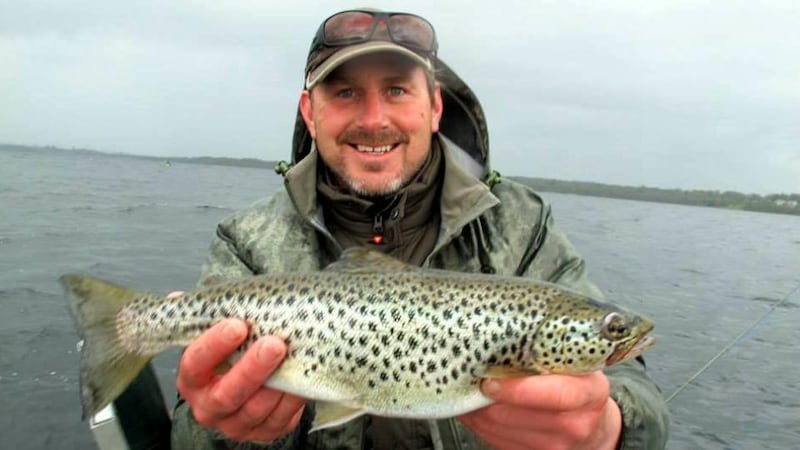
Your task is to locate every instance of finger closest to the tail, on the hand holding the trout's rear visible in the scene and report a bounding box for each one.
[177,319,247,391]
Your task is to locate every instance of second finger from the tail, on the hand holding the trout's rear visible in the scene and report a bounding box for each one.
[206,336,286,413]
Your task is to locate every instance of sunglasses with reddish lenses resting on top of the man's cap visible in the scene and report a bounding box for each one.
[310,10,438,55]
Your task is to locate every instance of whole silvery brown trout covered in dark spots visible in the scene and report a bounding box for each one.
[61,249,654,431]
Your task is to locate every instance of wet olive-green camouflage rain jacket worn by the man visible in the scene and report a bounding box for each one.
[172,58,669,450]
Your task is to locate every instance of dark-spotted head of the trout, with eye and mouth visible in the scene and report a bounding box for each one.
[531,298,655,374]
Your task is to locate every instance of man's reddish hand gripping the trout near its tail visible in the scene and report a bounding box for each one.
[176,319,305,442]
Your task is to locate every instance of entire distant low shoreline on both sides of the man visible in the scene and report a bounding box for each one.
[0,144,800,215]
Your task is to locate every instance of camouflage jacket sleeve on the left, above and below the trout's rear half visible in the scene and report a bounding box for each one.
[171,226,305,450]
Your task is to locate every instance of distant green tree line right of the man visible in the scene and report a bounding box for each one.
[510,177,800,215]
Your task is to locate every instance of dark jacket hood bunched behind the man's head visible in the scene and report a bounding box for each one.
[292,59,489,178]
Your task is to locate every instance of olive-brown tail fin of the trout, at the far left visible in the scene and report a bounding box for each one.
[60,274,153,420]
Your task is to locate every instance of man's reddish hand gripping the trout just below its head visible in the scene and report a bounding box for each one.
[459,371,622,450]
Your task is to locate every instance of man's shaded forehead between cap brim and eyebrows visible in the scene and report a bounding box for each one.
[322,53,425,83]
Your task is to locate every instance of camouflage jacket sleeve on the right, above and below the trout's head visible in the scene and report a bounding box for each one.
[519,206,670,450]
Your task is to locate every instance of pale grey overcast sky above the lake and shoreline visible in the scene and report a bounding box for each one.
[0,0,800,193]
